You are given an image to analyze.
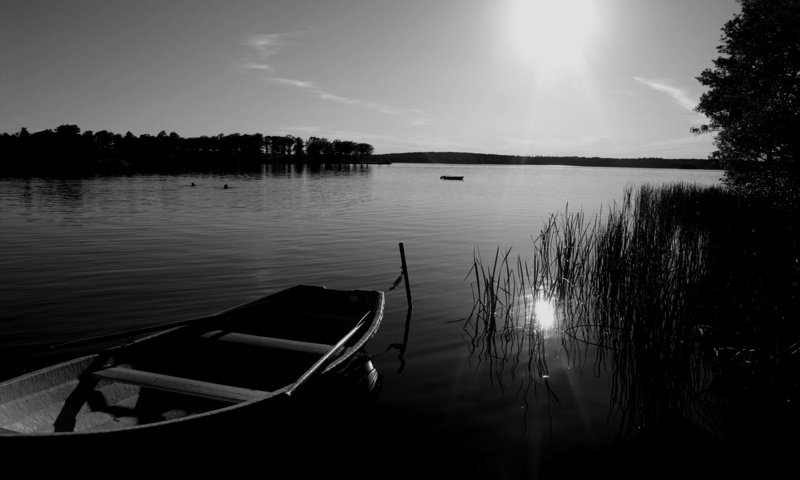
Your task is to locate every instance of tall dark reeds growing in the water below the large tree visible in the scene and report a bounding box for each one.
[465,184,800,440]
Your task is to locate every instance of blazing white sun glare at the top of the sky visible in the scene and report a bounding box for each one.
[507,0,596,72]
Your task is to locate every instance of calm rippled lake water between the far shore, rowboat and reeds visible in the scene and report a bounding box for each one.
[0,164,721,478]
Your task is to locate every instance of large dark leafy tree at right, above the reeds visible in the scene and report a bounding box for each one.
[693,0,800,201]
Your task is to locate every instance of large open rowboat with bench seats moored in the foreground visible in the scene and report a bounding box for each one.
[0,285,384,451]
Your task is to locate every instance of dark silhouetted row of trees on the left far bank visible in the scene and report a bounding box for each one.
[0,125,374,176]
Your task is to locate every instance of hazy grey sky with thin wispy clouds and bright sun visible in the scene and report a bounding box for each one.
[0,0,739,158]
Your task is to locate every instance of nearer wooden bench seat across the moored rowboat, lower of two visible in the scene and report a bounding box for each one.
[91,367,273,403]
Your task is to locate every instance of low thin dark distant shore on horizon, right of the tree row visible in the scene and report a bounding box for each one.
[369,152,721,170]
